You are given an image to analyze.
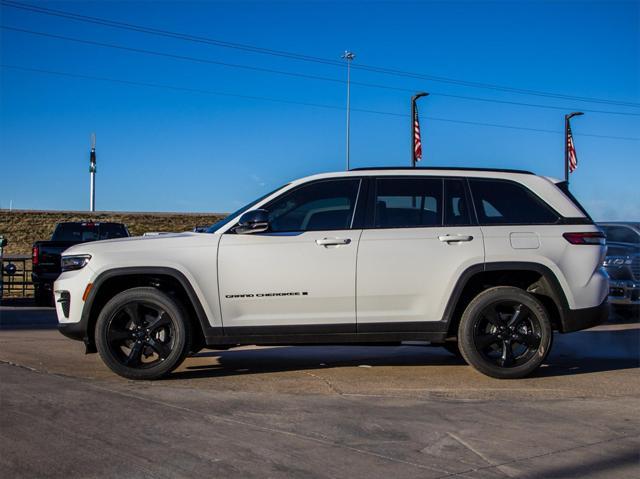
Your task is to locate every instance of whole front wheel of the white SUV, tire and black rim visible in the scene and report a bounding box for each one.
[96,288,191,379]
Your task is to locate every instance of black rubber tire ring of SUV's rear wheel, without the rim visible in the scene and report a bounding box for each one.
[458,286,553,379]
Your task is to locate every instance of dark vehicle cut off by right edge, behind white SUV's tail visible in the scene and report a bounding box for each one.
[599,221,640,315]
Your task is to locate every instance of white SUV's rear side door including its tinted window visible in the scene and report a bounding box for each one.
[357,176,484,333]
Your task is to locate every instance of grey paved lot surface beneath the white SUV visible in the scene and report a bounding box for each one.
[0,306,640,478]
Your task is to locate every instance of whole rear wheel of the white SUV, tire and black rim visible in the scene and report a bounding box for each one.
[458,286,553,379]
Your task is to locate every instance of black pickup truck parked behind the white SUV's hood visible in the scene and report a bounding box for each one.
[31,221,130,306]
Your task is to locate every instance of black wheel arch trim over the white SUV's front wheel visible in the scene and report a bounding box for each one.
[80,266,215,353]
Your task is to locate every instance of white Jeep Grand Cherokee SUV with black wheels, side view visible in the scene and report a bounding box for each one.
[54,168,609,379]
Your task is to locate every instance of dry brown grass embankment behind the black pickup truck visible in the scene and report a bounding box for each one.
[0,210,224,255]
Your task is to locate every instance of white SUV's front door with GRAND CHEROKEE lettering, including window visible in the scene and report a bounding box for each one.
[218,179,361,334]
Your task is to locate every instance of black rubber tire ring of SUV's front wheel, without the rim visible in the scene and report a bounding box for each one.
[95,288,191,379]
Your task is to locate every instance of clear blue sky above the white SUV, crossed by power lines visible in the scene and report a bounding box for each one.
[0,0,640,220]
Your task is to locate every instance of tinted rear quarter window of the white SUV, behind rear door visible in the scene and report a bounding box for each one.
[469,179,559,225]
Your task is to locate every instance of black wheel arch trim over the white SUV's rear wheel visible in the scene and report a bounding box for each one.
[443,261,569,337]
